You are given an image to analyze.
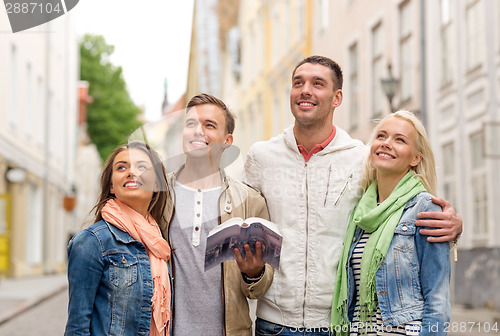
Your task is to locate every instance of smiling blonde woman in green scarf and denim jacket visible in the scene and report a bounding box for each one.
[332,111,450,335]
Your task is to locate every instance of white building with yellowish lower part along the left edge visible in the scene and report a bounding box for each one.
[0,11,78,277]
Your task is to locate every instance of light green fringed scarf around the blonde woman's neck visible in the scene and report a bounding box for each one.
[332,171,426,335]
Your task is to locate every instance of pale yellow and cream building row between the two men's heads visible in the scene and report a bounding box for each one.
[186,0,313,157]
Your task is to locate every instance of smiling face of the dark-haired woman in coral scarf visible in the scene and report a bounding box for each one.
[110,149,156,215]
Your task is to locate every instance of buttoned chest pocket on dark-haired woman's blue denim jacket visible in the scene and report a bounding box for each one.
[109,253,138,288]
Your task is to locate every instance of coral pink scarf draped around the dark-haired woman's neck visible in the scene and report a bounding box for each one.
[101,199,171,336]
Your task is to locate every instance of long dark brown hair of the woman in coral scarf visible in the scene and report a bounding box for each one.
[92,141,169,228]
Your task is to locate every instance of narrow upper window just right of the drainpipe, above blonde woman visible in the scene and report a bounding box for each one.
[441,0,453,86]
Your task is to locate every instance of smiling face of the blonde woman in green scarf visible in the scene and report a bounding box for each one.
[370,117,421,178]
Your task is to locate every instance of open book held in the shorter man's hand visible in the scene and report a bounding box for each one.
[205,217,283,271]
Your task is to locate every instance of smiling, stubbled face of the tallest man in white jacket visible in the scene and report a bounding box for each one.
[290,63,342,129]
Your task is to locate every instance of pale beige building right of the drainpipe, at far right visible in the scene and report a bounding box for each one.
[426,0,500,310]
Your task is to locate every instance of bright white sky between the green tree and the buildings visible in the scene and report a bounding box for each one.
[72,0,194,121]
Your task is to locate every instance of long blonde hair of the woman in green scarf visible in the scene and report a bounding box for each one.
[361,110,436,195]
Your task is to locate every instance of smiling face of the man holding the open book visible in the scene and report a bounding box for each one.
[182,104,233,157]
